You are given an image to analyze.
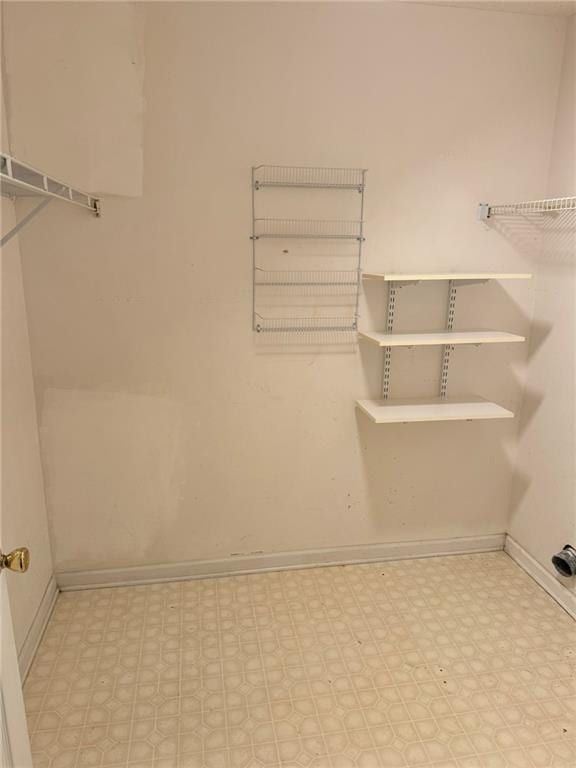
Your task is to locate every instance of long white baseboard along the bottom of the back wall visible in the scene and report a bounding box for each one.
[56,533,506,591]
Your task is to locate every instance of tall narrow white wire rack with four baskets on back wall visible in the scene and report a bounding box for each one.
[251,165,366,334]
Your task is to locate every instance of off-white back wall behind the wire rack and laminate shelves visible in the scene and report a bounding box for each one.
[12,3,563,571]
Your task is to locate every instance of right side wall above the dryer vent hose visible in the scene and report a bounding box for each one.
[510,16,576,593]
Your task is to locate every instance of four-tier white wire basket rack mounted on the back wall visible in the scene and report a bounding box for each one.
[251,165,366,334]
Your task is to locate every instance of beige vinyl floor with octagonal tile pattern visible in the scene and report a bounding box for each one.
[25,552,576,768]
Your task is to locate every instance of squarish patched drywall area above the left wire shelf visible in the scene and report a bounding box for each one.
[2,2,144,195]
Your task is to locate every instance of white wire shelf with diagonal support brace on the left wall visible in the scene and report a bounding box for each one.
[0,154,100,245]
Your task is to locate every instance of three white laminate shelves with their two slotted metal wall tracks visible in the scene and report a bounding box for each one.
[356,272,532,424]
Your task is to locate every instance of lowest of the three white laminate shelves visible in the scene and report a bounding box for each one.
[356,397,514,424]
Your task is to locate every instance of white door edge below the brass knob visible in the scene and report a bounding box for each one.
[0,557,32,768]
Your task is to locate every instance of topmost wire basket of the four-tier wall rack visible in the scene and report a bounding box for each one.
[254,165,366,192]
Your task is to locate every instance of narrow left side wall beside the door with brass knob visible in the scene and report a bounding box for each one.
[0,13,56,660]
